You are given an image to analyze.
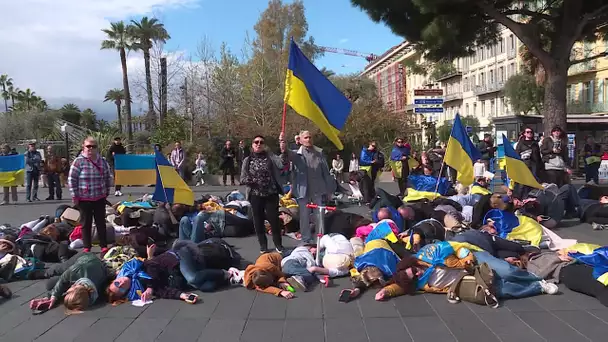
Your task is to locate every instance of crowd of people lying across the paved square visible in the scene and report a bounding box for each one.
[0,178,608,313]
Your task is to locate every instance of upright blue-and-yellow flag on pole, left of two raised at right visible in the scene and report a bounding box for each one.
[443,114,481,186]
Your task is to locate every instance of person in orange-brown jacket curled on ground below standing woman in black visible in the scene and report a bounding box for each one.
[243,252,294,299]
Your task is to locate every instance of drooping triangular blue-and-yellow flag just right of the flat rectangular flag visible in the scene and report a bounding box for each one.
[152,149,194,205]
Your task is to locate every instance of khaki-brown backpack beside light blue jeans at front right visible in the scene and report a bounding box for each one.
[447,262,499,309]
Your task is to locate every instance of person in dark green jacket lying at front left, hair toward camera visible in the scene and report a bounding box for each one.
[30,252,111,312]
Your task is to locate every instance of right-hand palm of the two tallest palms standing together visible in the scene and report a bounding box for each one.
[131,17,171,128]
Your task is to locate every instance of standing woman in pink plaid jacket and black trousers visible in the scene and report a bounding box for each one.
[68,137,112,256]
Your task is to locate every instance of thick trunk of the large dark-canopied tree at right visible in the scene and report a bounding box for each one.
[543,64,568,137]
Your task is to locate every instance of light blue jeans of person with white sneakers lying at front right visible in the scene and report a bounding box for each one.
[473,252,542,298]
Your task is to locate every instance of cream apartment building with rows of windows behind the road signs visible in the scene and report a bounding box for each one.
[362,29,521,136]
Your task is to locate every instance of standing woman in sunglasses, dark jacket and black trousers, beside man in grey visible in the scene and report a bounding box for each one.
[241,135,283,253]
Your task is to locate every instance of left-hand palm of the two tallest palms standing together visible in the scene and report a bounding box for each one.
[101,21,133,141]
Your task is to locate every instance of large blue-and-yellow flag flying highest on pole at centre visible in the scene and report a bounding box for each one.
[285,40,352,150]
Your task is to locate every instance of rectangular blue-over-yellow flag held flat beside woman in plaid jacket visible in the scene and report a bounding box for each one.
[114,154,156,185]
